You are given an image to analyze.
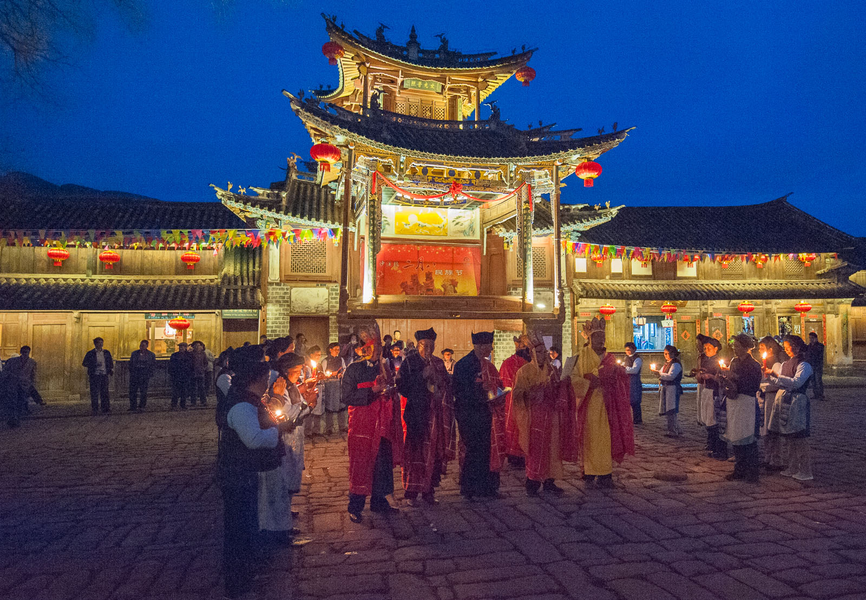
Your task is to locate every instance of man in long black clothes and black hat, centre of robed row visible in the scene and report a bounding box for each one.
[452,331,502,501]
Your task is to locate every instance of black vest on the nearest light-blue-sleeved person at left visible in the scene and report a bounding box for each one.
[217,386,285,480]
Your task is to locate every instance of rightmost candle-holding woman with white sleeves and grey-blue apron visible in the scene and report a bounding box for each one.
[764,335,813,481]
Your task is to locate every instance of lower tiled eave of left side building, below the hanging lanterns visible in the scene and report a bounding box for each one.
[0,276,261,311]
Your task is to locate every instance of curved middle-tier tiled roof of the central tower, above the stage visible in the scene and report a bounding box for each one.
[284,99,629,162]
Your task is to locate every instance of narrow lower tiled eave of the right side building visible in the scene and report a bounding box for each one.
[574,279,866,301]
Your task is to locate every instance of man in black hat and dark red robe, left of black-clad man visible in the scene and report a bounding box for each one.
[396,328,456,506]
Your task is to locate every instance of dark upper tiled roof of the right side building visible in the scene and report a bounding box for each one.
[580,196,859,258]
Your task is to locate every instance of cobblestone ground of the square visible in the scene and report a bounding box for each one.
[0,389,866,600]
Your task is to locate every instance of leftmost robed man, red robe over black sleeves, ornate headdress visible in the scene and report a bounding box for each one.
[343,322,403,523]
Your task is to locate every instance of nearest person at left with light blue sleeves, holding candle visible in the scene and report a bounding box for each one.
[217,361,290,598]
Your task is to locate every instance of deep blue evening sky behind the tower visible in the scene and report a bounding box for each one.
[0,0,866,236]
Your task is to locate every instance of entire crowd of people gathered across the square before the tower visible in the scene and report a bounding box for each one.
[0,317,824,597]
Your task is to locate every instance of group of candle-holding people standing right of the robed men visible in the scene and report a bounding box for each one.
[624,332,824,483]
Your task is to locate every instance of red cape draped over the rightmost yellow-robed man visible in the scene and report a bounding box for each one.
[577,354,634,463]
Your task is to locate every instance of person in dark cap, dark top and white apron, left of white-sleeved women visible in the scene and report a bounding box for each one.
[720,333,763,483]
